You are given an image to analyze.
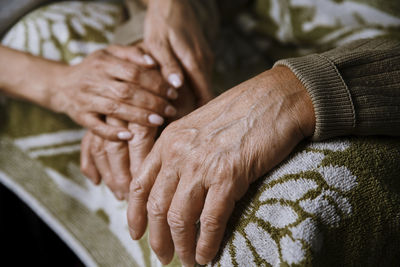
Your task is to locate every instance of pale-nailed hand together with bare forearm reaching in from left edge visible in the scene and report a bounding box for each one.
[0,44,178,140]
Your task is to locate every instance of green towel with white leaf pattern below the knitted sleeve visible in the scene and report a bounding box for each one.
[210,138,400,266]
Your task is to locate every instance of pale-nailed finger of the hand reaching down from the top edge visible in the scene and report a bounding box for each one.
[145,39,183,88]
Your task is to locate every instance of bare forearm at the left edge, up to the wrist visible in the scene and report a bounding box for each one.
[0,46,65,108]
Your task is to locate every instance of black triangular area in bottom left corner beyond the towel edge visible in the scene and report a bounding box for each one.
[0,184,84,267]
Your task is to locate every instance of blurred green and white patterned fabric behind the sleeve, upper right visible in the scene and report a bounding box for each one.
[239,0,400,60]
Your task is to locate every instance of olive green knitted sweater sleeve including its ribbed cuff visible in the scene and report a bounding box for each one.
[275,38,400,140]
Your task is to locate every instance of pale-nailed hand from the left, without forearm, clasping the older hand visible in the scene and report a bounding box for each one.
[50,46,177,141]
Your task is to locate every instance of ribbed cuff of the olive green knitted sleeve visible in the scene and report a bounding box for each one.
[274,54,356,141]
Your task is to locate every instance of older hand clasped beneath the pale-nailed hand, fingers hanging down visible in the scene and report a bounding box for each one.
[81,82,195,200]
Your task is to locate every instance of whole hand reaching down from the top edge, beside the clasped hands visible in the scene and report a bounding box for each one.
[144,0,213,105]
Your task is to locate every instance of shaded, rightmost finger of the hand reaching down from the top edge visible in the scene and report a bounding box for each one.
[171,35,214,105]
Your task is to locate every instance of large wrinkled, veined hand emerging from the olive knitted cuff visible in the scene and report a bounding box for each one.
[128,67,315,266]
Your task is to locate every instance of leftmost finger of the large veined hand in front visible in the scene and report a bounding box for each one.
[127,146,161,240]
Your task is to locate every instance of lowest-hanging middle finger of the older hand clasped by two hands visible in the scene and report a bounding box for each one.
[104,117,131,200]
